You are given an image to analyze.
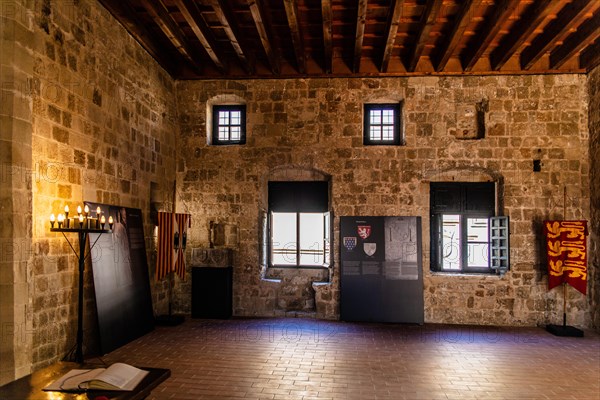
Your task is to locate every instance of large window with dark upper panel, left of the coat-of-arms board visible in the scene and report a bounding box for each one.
[269,181,331,267]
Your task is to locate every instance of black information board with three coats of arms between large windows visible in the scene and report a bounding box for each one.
[340,216,424,324]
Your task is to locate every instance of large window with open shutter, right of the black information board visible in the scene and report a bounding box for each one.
[431,182,508,273]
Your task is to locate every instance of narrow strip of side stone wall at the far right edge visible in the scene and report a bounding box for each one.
[588,67,600,331]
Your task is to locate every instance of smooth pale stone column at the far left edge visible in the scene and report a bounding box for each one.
[0,0,34,385]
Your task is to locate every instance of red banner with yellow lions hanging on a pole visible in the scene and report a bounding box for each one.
[544,221,588,294]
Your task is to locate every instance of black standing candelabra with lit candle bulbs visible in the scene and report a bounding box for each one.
[50,205,113,364]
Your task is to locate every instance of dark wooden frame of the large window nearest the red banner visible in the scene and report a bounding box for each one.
[430,182,498,274]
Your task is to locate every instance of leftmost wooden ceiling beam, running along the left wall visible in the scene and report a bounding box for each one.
[100,0,179,77]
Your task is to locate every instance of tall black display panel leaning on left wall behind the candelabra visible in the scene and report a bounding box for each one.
[85,202,154,353]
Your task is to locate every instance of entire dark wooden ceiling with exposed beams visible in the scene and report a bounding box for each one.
[100,0,600,79]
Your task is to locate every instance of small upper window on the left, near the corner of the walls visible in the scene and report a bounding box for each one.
[212,105,246,145]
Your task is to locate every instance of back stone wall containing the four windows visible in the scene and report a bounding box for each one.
[177,75,591,326]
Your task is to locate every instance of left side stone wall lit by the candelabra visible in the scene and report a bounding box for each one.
[2,0,177,376]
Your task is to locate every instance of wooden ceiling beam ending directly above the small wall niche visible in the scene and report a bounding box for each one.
[461,0,521,71]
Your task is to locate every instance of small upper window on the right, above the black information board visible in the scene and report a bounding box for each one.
[363,103,403,145]
